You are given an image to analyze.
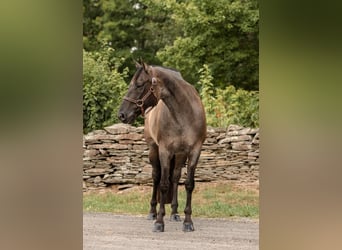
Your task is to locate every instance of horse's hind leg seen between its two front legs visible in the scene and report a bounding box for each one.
[170,154,186,221]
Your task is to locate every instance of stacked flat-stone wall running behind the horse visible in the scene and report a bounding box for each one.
[83,124,259,190]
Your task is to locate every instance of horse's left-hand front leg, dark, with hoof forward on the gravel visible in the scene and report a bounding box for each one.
[153,150,171,232]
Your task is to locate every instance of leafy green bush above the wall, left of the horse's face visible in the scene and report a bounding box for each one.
[83,46,127,133]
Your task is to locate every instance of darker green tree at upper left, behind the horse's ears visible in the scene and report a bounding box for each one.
[83,0,175,77]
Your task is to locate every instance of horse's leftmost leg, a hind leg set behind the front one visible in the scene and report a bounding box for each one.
[147,144,160,220]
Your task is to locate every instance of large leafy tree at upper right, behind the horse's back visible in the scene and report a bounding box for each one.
[157,0,259,90]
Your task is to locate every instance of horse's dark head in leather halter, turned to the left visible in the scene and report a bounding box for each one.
[118,62,158,124]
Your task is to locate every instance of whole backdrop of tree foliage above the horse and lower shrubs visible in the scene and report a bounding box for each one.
[83,0,259,90]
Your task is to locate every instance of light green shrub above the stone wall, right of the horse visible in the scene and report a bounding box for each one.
[199,65,259,127]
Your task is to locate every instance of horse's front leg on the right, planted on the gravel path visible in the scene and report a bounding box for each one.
[183,149,201,232]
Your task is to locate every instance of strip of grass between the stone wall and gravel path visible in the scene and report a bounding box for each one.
[83,183,259,218]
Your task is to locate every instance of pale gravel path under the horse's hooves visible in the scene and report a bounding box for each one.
[83,212,259,250]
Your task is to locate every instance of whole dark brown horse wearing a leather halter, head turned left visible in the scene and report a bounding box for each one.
[119,62,206,232]
